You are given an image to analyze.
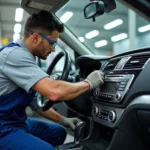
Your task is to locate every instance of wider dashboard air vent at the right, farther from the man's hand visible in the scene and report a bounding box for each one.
[123,53,150,69]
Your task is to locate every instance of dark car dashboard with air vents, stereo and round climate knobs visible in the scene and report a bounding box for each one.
[77,48,150,128]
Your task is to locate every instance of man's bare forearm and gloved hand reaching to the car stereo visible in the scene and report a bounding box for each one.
[32,71,103,101]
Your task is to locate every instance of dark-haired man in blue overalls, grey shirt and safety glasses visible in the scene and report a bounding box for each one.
[0,11,103,150]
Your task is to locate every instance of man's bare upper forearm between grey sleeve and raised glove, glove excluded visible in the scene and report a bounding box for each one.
[33,77,89,101]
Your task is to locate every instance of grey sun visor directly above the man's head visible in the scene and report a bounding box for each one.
[21,0,69,14]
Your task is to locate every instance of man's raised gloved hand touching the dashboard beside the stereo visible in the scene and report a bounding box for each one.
[84,70,104,90]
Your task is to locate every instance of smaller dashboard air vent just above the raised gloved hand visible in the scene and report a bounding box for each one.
[104,59,120,71]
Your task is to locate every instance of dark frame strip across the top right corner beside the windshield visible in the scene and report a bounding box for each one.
[118,0,150,21]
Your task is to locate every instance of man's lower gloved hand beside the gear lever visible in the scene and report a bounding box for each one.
[59,116,80,130]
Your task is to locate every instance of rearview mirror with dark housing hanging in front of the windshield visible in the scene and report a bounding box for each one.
[84,1,105,21]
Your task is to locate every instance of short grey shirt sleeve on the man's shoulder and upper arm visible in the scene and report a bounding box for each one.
[2,48,48,92]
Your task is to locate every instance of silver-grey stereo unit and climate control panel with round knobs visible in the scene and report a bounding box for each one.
[92,74,135,127]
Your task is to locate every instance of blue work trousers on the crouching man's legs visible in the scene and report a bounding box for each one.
[0,119,66,150]
